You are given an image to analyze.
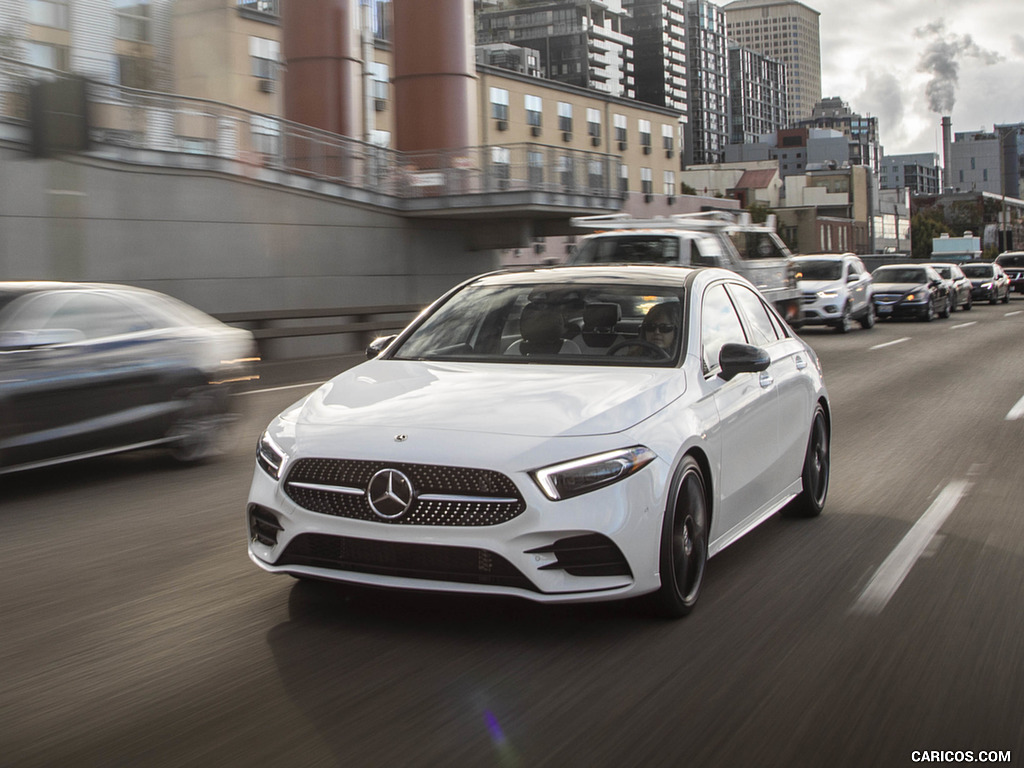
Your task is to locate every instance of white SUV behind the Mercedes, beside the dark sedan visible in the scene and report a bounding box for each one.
[793,253,874,334]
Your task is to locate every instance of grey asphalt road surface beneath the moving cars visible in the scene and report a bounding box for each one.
[0,298,1024,768]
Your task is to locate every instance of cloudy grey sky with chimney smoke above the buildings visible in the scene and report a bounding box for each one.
[801,0,1024,155]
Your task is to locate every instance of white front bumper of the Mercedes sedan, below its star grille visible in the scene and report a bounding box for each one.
[247,450,669,603]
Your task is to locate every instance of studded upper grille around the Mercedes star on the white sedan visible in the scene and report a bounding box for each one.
[285,459,526,526]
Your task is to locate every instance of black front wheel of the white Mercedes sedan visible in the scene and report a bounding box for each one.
[654,456,709,617]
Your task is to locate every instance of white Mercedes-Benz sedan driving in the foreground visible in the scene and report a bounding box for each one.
[247,266,831,615]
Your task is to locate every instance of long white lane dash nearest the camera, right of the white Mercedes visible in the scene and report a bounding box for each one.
[851,480,971,614]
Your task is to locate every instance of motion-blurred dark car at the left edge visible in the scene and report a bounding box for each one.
[0,282,256,474]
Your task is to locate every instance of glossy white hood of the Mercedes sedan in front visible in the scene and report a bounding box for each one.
[283,359,686,436]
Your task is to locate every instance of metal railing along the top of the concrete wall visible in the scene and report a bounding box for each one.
[0,56,623,200]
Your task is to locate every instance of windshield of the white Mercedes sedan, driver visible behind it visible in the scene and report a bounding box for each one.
[389,283,685,366]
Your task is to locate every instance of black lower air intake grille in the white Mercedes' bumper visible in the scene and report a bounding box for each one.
[275,534,538,592]
